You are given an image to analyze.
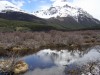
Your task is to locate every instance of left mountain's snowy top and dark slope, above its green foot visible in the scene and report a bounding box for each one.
[0,0,45,21]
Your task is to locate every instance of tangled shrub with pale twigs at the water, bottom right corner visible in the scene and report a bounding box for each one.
[64,61,100,75]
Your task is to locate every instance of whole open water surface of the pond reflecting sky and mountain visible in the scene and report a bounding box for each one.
[22,48,100,75]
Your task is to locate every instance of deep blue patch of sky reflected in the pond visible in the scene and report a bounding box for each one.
[24,55,55,69]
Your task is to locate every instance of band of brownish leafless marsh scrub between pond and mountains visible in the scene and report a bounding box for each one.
[0,30,100,56]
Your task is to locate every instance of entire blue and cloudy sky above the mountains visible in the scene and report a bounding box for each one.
[2,0,100,20]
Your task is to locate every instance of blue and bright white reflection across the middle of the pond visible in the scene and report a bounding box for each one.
[22,49,79,69]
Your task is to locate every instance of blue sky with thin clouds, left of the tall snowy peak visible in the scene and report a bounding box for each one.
[7,0,73,12]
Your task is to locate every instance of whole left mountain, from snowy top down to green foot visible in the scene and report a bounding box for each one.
[0,0,55,32]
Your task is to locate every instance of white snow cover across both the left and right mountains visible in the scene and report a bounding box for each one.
[0,0,100,24]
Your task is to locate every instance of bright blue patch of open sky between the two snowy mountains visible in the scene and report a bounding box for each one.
[22,0,52,12]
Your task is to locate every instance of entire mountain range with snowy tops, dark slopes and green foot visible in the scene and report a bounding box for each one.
[0,0,100,31]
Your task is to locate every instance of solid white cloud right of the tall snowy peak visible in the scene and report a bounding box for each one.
[72,0,100,20]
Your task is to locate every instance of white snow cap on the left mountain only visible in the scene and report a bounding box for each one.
[0,0,22,13]
